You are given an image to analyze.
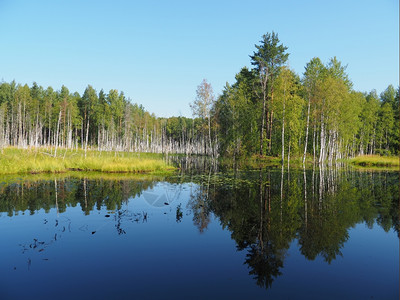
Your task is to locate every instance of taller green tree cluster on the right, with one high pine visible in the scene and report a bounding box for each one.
[210,32,399,163]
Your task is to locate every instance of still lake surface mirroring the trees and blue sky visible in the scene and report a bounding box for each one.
[0,169,399,299]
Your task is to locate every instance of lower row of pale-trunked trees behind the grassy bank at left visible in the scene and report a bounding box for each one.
[0,81,209,155]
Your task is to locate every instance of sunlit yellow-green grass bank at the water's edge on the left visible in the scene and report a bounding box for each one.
[0,147,174,174]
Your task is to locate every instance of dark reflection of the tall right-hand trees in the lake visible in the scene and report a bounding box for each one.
[191,169,399,288]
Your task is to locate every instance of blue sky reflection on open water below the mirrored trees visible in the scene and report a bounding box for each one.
[0,182,399,299]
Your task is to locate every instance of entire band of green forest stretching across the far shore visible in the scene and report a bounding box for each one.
[0,32,399,163]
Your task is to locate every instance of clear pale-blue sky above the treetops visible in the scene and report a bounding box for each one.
[0,0,399,117]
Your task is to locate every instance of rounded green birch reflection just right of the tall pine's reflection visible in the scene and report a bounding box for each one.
[299,169,350,263]
